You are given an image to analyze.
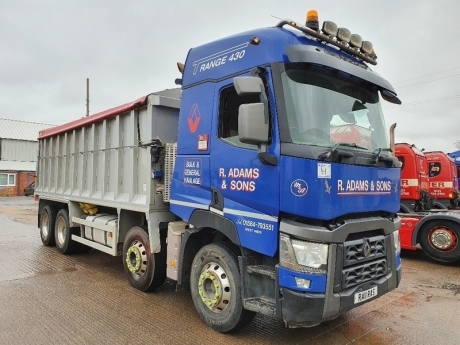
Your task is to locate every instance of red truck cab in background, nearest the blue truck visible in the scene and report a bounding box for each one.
[395,143,434,213]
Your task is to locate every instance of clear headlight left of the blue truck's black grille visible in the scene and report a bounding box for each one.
[279,234,329,273]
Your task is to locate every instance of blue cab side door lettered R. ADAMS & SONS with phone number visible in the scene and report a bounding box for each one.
[210,74,280,256]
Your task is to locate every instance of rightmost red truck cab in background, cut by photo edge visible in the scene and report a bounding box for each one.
[425,151,460,209]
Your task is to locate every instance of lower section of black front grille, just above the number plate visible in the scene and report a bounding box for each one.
[342,259,387,289]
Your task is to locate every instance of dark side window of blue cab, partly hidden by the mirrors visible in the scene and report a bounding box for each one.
[218,86,260,150]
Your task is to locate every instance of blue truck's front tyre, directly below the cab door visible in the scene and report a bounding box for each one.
[190,242,255,333]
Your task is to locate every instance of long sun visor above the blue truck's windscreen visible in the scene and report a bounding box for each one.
[286,45,396,95]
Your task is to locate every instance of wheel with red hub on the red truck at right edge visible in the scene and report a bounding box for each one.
[420,219,460,262]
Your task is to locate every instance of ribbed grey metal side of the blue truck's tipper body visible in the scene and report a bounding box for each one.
[36,92,178,209]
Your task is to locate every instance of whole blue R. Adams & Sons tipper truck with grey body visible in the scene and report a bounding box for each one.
[35,12,401,332]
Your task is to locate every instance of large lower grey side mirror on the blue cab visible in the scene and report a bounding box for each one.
[238,103,269,145]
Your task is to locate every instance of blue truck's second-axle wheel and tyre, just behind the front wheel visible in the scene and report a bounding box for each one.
[123,226,166,291]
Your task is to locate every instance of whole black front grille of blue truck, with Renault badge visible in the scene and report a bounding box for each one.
[334,234,389,292]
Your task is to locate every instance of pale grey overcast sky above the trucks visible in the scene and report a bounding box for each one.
[0,0,460,152]
